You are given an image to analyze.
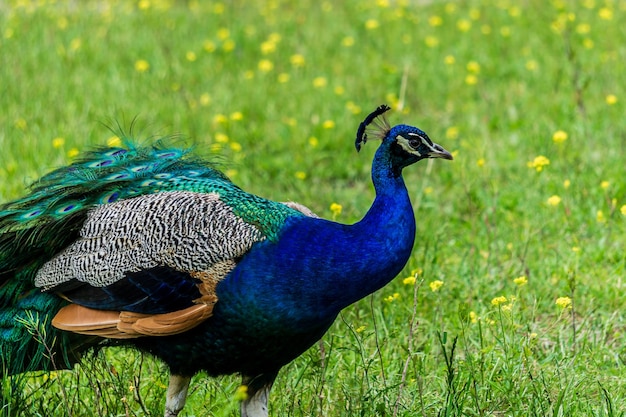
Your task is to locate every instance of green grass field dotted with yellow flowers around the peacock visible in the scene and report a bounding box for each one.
[0,0,626,416]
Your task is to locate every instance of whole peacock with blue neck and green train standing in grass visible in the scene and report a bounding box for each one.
[0,105,452,417]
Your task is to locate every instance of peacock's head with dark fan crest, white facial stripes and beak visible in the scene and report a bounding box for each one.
[355,104,452,171]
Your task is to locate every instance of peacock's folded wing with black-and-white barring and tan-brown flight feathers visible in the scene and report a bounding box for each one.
[35,191,265,338]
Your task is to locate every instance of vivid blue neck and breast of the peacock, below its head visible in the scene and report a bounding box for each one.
[218,144,415,329]
